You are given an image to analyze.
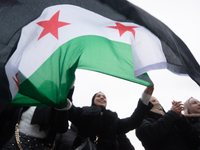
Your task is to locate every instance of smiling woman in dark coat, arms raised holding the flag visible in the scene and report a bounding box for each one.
[63,86,154,150]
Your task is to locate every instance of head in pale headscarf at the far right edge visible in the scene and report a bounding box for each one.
[184,97,200,114]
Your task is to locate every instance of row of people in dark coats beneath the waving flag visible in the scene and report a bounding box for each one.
[0,82,200,150]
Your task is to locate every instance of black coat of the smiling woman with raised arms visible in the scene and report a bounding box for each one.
[69,101,153,150]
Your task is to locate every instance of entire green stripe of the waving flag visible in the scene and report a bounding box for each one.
[12,35,150,108]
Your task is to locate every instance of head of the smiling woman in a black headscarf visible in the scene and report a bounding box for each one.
[92,92,107,108]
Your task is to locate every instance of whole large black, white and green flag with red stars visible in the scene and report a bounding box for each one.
[0,0,200,112]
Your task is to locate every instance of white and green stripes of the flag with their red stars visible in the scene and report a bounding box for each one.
[5,5,155,107]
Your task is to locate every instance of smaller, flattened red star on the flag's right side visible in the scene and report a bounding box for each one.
[108,22,138,37]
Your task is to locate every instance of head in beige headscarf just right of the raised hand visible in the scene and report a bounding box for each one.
[149,96,165,115]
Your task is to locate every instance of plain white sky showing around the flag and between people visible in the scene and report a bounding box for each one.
[73,0,200,150]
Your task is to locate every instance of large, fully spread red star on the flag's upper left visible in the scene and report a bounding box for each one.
[37,11,70,40]
